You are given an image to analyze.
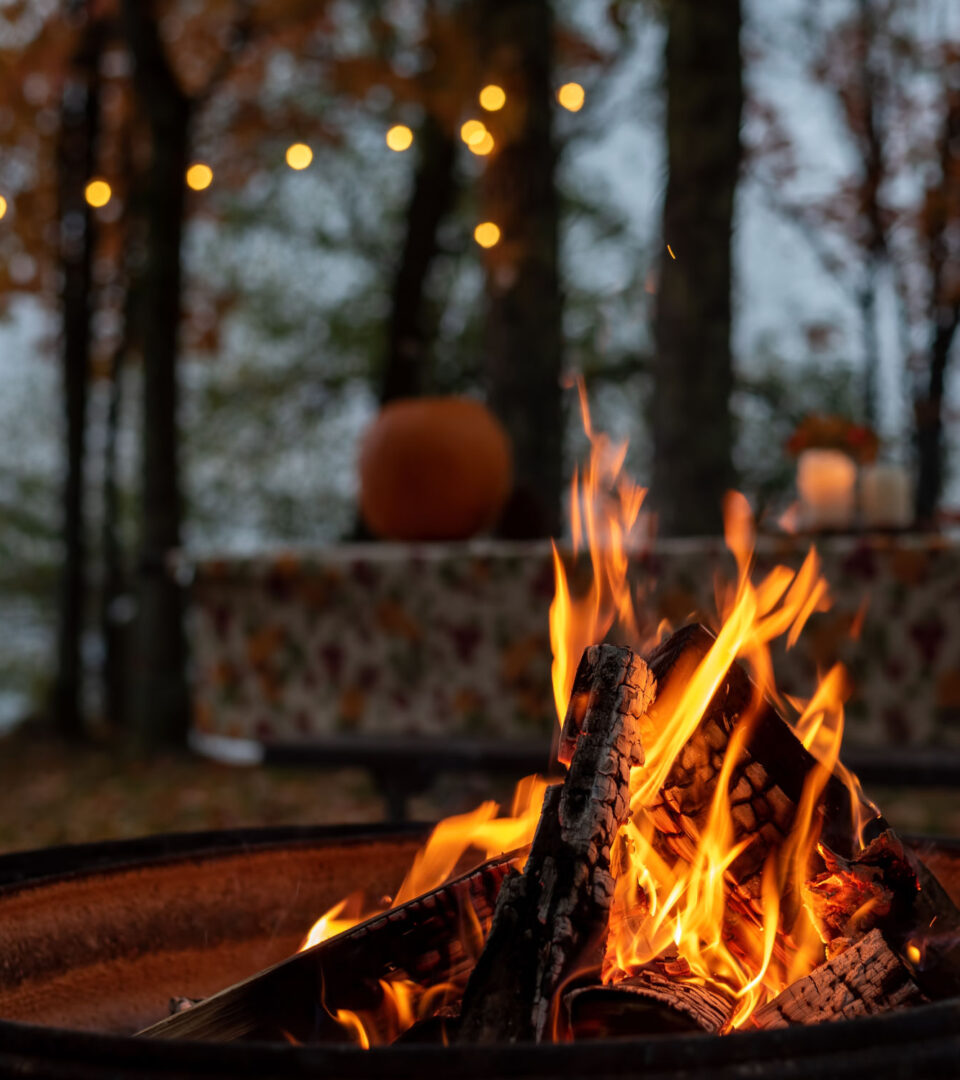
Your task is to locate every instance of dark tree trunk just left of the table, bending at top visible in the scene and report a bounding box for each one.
[123,0,191,745]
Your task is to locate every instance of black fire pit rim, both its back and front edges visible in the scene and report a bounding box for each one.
[0,823,960,1080]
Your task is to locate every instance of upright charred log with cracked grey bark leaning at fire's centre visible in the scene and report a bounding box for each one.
[459,645,655,1042]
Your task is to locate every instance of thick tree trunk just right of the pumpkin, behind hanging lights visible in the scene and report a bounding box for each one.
[478,0,564,537]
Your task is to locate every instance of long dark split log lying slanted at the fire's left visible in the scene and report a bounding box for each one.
[139,853,519,1042]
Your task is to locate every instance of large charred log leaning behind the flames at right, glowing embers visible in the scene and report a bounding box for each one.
[634,625,960,997]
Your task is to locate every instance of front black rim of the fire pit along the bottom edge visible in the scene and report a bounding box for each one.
[0,998,960,1080]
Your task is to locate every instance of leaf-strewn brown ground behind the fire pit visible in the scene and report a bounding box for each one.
[0,731,960,851]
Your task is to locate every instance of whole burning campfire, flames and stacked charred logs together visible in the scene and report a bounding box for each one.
[143,393,960,1048]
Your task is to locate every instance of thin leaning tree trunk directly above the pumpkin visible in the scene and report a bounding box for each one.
[380,114,457,404]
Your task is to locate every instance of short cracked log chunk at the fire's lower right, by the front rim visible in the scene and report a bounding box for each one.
[749,930,925,1028]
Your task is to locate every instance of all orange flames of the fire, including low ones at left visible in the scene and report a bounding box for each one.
[303,382,876,1045]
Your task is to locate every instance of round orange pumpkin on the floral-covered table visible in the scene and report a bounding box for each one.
[360,397,513,540]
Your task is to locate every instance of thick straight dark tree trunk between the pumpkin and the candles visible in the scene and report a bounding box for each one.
[652,0,743,535]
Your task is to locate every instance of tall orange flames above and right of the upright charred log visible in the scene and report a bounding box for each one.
[551,414,868,1028]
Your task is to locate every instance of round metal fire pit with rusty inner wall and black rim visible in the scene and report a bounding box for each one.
[0,826,960,1080]
